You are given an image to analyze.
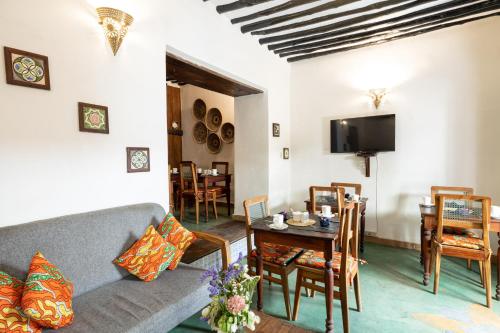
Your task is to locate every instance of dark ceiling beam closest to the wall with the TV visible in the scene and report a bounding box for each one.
[287,12,500,62]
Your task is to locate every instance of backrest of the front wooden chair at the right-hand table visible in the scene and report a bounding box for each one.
[436,194,491,250]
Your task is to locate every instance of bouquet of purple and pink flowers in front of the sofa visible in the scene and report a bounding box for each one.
[201,253,260,333]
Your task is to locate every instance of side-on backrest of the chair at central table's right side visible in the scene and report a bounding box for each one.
[340,202,359,277]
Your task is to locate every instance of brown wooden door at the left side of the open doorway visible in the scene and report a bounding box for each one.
[167,86,183,172]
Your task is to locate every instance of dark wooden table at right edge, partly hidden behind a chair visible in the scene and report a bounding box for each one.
[420,205,500,300]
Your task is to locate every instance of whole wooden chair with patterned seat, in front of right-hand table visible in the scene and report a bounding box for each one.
[432,194,491,308]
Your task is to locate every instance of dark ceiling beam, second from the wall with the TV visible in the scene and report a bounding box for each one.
[274,4,500,57]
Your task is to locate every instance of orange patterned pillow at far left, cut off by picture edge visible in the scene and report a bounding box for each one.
[0,272,42,333]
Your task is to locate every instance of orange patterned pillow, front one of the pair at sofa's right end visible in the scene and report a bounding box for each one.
[114,225,177,281]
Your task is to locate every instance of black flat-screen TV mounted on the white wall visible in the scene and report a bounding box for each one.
[330,114,396,153]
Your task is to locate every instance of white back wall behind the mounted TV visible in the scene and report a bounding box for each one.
[291,18,500,243]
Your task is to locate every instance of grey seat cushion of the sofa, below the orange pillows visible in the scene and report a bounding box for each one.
[44,264,210,333]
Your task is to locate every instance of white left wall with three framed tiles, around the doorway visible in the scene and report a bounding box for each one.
[0,0,290,226]
